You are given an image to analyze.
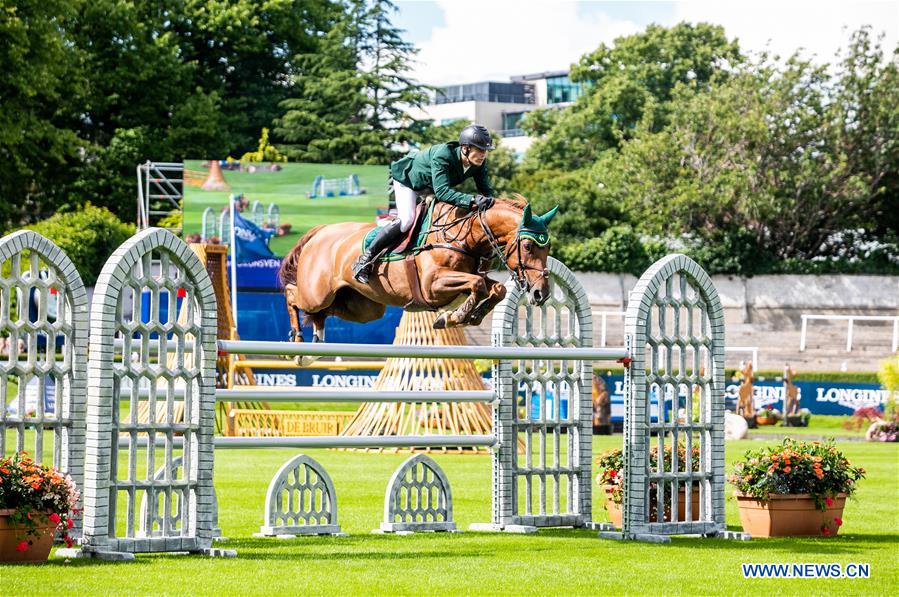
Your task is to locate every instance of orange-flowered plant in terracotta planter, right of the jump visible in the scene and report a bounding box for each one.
[729,438,865,537]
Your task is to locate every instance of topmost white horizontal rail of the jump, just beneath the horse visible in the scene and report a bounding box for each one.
[218,340,627,361]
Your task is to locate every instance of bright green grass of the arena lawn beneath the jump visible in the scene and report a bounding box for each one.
[0,436,899,595]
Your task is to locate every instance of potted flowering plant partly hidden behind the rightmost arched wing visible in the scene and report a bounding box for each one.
[596,445,699,527]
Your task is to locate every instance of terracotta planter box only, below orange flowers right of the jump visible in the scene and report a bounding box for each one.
[734,491,846,537]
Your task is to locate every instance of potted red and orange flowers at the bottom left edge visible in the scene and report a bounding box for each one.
[0,452,79,562]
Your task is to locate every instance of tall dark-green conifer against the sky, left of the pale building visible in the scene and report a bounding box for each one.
[274,0,426,163]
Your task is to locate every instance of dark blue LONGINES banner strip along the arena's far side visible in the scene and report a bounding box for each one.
[254,368,889,421]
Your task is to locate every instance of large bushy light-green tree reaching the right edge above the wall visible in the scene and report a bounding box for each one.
[602,32,899,273]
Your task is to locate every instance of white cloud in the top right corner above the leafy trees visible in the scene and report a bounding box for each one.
[674,0,899,62]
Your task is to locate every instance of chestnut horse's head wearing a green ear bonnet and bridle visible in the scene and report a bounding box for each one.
[507,204,559,305]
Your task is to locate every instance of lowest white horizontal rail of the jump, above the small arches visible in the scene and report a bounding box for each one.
[118,433,497,449]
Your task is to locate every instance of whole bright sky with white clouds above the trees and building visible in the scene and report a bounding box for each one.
[393,0,899,85]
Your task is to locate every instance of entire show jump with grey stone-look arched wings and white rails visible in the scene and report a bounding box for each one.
[0,228,738,559]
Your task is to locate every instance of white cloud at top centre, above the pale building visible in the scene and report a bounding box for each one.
[415,0,642,85]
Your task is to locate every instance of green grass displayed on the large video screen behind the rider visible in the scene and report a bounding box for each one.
[184,161,387,255]
